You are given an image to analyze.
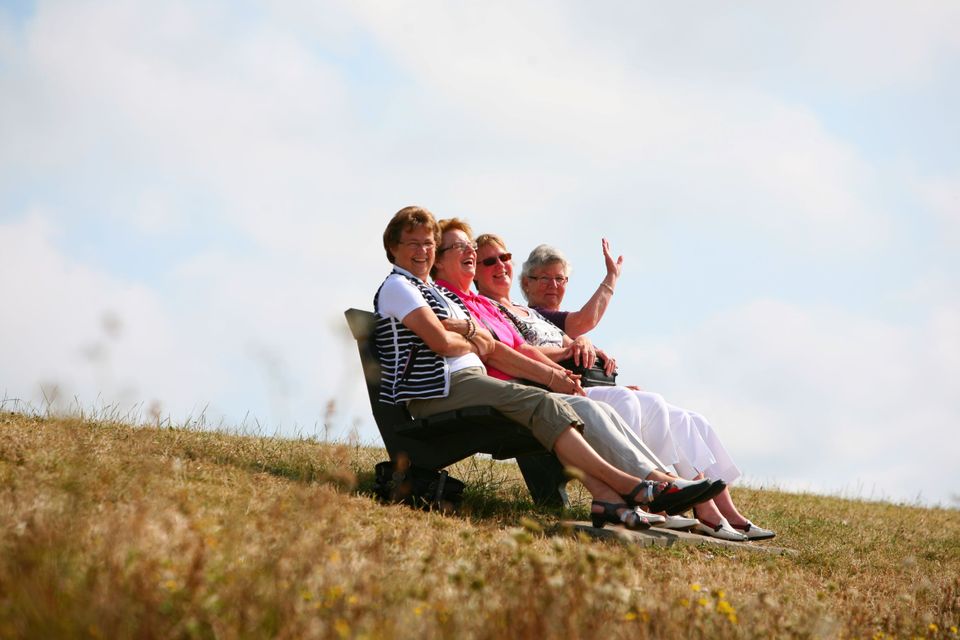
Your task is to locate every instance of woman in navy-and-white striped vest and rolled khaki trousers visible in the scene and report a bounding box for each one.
[374,207,715,529]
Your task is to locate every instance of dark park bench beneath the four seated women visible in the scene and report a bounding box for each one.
[344,309,569,506]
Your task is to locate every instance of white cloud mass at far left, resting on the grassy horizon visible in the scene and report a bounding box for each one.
[0,212,219,418]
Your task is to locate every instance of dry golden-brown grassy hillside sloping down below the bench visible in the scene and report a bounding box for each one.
[0,413,960,639]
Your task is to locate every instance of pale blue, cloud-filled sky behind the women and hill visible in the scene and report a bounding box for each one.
[0,0,960,507]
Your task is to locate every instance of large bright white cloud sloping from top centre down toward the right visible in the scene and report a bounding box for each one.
[346,4,888,252]
